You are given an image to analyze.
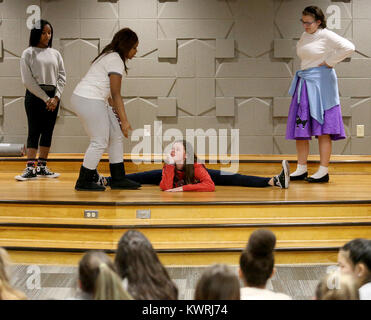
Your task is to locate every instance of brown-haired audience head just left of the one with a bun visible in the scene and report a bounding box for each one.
[195,264,240,300]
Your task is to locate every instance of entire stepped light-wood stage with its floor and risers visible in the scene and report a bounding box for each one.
[0,154,371,265]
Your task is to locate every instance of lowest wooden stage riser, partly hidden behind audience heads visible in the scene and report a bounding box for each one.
[9,250,338,266]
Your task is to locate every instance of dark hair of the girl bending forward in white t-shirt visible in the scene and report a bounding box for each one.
[92,28,138,73]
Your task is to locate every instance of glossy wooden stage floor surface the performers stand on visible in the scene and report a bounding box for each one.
[0,172,371,203]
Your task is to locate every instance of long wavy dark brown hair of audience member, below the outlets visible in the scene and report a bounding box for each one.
[115,230,178,300]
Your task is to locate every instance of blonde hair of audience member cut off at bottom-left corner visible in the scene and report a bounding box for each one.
[0,247,26,300]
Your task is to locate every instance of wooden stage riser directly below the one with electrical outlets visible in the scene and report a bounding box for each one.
[0,226,371,249]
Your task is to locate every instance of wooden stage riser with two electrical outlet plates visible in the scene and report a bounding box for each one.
[0,203,371,226]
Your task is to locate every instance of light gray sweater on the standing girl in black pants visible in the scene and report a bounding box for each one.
[20,47,66,102]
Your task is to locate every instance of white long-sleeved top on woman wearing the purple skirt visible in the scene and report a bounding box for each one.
[296,28,355,70]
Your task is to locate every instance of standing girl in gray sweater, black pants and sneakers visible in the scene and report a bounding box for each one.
[15,20,66,181]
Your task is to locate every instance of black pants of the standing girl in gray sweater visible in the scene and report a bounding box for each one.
[24,86,59,149]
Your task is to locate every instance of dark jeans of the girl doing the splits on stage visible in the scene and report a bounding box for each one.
[126,169,271,188]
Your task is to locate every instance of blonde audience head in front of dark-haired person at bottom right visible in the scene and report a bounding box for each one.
[316,272,359,300]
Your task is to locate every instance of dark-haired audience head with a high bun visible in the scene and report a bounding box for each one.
[240,229,276,288]
